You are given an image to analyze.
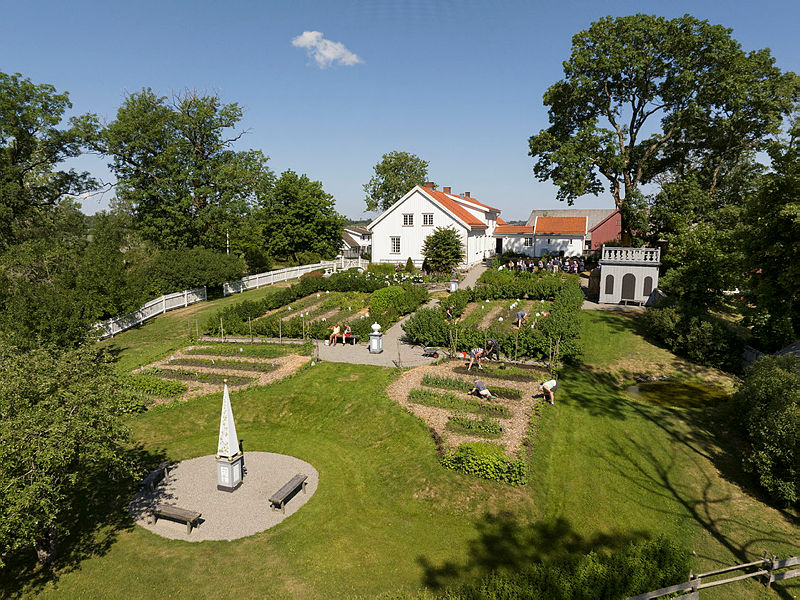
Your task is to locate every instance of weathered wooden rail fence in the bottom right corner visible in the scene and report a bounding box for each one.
[626,552,800,600]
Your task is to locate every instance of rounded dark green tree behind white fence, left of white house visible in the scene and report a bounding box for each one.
[261,170,345,260]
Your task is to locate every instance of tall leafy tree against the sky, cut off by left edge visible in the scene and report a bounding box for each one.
[0,73,95,251]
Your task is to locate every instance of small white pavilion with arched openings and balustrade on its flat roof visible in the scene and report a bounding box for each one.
[599,246,661,304]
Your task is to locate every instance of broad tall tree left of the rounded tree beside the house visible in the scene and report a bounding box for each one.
[91,89,274,251]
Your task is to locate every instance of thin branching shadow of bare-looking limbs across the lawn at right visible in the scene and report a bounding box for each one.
[596,439,796,600]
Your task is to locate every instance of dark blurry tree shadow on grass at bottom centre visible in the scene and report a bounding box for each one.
[417,511,648,590]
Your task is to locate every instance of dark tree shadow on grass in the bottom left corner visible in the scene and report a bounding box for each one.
[0,447,166,598]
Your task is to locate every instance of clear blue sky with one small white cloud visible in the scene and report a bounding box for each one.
[0,0,800,220]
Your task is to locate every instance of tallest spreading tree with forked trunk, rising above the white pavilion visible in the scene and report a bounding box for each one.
[530,14,795,233]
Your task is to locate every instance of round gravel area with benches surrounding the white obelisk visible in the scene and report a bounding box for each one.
[128,452,319,542]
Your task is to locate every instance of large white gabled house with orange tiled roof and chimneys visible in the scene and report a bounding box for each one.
[367,185,500,267]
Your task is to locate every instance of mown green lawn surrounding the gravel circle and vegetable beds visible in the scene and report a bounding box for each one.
[7,296,800,600]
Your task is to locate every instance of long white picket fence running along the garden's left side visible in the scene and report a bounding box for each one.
[95,258,369,339]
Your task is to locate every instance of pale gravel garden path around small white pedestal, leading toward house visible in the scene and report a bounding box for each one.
[316,263,486,367]
